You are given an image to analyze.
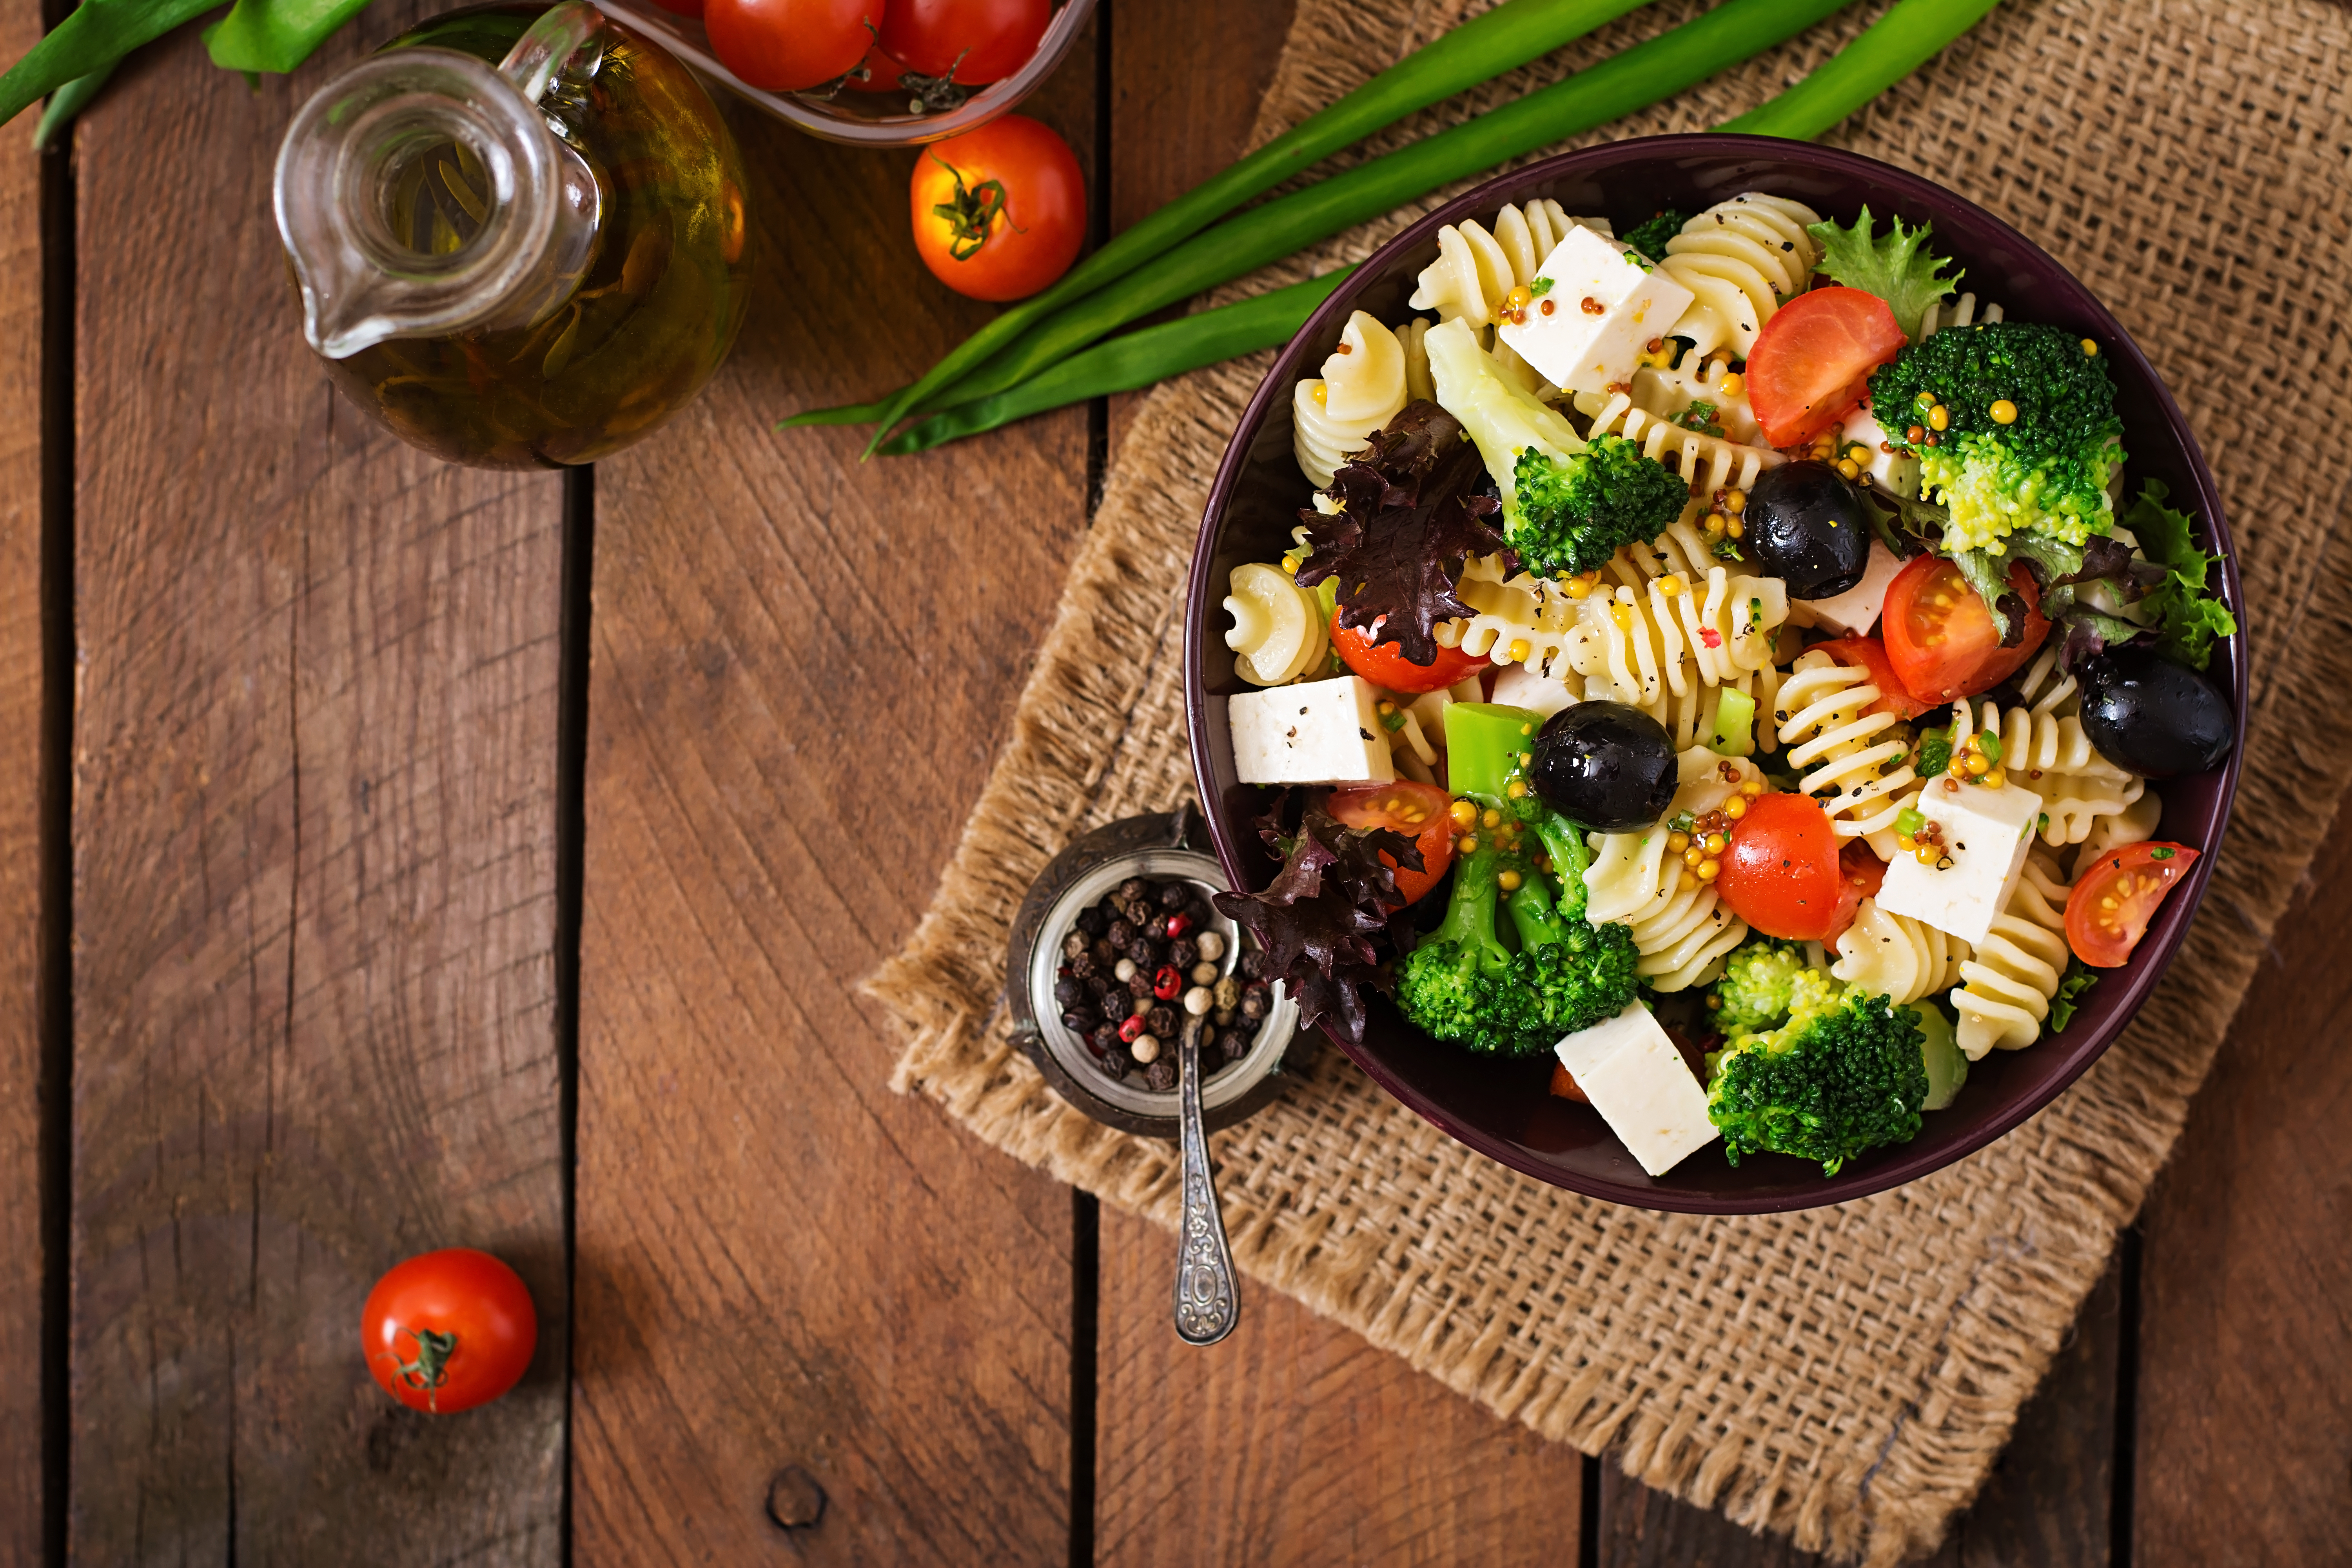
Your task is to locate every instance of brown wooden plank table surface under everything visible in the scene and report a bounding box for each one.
[0,0,2352,1568]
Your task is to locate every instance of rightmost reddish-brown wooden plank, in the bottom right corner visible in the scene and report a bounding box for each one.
[2133,846,2352,1568]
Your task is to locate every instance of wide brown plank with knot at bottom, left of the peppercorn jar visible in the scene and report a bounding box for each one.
[574,15,1096,1566]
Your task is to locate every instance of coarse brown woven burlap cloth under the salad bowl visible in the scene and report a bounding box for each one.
[870,0,2352,1563]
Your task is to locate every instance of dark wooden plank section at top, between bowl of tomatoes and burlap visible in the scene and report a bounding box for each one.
[1103,0,1296,458]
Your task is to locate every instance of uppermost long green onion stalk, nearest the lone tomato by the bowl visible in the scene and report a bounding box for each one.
[781,0,1646,451]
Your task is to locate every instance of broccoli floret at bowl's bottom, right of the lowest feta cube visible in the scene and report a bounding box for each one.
[1708,987,1929,1176]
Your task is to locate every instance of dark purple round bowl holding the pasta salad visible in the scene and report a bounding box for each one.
[1185,136,2246,1213]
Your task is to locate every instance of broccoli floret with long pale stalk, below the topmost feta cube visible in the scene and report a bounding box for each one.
[1423,320,1691,576]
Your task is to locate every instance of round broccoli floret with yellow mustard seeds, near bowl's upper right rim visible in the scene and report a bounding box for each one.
[1870,322,2124,552]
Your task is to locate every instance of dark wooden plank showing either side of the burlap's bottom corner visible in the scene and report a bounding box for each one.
[1599,1258,2124,1568]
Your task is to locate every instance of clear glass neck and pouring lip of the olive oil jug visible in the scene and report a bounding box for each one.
[275,0,602,360]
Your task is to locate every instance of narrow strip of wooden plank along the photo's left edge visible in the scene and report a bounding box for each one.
[0,0,45,1568]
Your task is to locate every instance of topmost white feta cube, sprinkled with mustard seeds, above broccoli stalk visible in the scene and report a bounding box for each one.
[1498,228,1691,392]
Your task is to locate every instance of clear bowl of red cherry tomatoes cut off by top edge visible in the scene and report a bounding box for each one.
[597,0,1094,148]
